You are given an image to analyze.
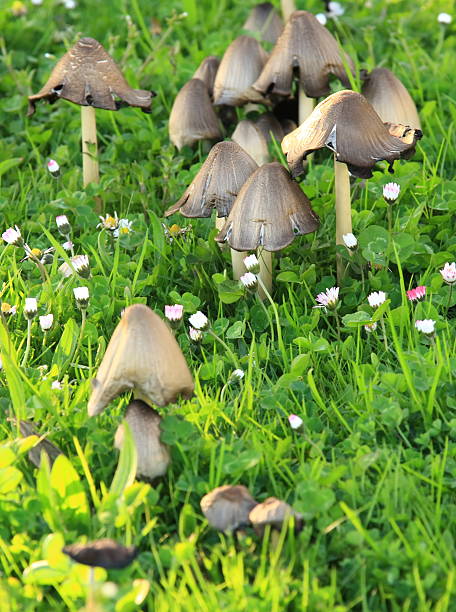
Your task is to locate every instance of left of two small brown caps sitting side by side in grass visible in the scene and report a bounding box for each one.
[200,485,257,531]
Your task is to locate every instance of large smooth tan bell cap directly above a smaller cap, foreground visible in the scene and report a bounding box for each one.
[88,304,193,416]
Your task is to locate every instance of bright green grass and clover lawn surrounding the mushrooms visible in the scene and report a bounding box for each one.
[0,0,456,612]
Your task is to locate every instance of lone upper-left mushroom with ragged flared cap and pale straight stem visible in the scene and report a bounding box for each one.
[28,38,155,198]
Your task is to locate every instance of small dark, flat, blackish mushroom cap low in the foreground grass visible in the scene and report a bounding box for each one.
[62,538,138,569]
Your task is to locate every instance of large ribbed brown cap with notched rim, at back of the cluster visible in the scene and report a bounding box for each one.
[253,11,354,98]
